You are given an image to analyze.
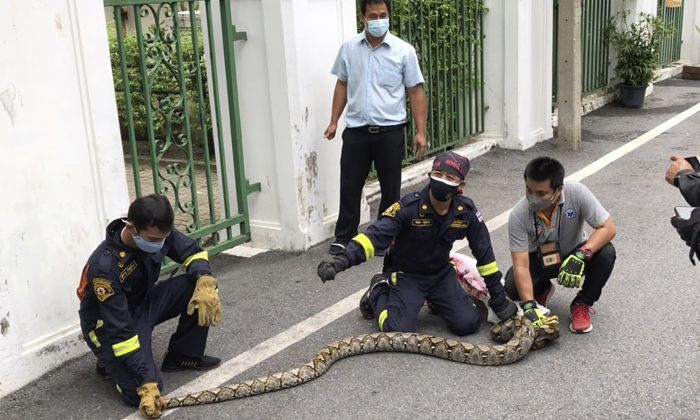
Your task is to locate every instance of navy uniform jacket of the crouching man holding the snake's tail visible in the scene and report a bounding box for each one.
[77,220,211,383]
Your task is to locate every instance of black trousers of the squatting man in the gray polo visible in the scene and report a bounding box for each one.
[506,243,617,306]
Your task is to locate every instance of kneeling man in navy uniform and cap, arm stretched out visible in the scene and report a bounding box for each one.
[317,152,517,336]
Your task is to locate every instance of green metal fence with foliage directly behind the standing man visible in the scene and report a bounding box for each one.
[357,0,486,176]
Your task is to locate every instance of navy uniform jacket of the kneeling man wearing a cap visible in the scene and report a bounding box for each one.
[342,186,505,297]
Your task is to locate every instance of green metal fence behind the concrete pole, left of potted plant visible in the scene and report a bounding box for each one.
[552,0,611,106]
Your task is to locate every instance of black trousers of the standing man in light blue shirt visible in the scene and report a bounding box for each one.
[335,128,406,243]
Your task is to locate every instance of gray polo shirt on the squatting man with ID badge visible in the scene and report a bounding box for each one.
[508,181,610,258]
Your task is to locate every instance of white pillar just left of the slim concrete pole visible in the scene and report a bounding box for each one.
[494,0,553,150]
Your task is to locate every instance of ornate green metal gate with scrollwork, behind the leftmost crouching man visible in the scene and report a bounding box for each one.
[104,0,260,269]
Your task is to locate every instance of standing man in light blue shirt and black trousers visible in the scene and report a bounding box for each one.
[323,0,426,255]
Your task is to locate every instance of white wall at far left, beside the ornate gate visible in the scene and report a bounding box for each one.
[0,0,128,396]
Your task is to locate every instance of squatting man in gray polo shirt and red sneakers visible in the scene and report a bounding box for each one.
[506,157,616,333]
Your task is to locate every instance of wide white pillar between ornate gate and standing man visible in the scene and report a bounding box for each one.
[215,0,369,250]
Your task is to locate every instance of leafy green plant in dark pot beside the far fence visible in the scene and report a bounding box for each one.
[605,10,675,108]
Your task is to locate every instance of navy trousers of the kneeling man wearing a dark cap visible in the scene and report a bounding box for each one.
[369,264,481,336]
